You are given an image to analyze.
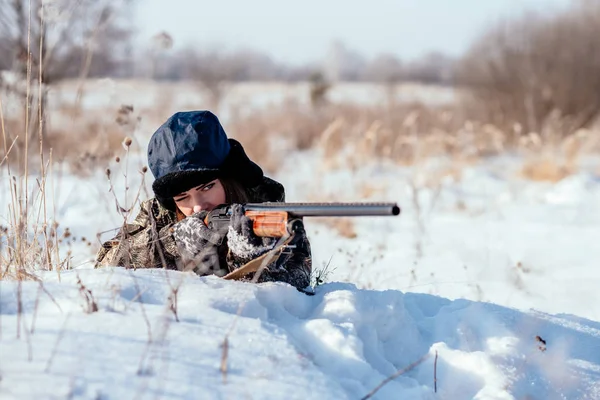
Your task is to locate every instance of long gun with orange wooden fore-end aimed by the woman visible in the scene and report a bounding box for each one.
[204,202,400,238]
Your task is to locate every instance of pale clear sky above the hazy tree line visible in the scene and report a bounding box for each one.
[136,0,568,64]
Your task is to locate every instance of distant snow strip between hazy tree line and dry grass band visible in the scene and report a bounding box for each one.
[0,75,457,122]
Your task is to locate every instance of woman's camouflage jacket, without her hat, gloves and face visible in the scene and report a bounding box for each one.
[96,177,312,289]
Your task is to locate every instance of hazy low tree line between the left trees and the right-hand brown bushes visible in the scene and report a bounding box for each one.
[138,43,454,84]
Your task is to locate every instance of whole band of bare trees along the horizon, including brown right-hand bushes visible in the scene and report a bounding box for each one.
[0,0,600,141]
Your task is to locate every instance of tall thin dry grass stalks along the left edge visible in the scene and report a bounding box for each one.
[0,0,80,281]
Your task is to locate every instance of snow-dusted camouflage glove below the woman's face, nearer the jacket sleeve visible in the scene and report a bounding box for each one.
[172,211,223,275]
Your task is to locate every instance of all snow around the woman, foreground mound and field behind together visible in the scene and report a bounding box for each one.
[0,82,600,399]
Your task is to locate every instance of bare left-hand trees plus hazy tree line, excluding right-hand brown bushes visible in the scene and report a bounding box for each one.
[0,0,453,84]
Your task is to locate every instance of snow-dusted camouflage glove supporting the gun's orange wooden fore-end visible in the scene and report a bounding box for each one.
[227,204,277,264]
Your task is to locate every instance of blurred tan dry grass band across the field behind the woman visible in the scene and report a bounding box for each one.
[6,78,600,186]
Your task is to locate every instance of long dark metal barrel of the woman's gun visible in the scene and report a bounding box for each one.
[245,202,400,217]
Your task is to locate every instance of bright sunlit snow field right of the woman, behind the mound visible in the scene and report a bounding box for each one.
[281,150,600,320]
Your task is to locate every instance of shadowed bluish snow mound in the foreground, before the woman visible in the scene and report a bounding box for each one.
[0,268,600,399]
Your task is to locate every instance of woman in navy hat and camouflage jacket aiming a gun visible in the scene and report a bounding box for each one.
[96,111,312,289]
